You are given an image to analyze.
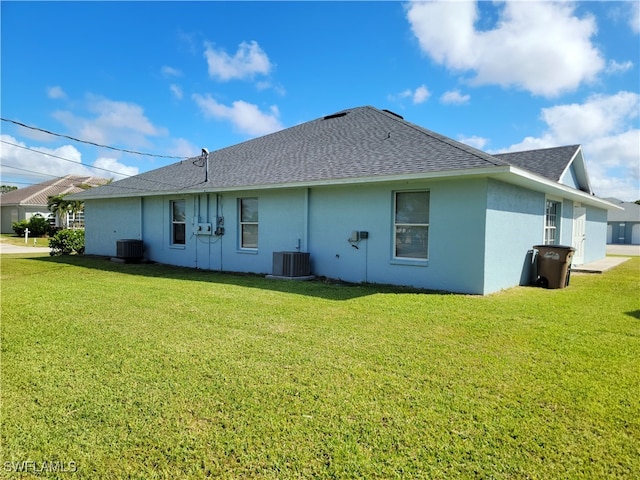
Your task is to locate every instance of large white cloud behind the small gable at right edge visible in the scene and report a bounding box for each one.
[501,92,640,201]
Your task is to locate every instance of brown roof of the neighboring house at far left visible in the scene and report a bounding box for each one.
[0,175,109,206]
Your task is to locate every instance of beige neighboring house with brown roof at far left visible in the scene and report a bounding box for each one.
[0,175,109,233]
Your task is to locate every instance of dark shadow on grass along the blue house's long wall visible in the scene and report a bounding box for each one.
[28,255,456,300]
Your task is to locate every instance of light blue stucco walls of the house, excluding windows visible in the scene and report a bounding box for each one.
[85,178,606,294]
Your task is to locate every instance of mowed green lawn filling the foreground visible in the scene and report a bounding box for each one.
[0,255,640,479]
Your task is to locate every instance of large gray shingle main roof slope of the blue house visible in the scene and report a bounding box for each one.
[74,107,508,198]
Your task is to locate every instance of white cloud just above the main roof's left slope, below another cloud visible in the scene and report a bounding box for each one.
[193,94,283,136]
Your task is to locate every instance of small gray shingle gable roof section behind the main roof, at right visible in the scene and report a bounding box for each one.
[494,145,580,182]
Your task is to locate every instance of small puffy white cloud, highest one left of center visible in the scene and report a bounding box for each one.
[204,41,272,81]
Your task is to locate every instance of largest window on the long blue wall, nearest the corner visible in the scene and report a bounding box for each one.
[394,192,429,260]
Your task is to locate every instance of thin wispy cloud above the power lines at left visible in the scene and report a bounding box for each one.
[53,95,168,149]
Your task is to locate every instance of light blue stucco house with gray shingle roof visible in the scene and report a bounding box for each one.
[73,107,616,294]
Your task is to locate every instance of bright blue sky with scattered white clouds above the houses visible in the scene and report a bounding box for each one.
[0,1,640,201]
